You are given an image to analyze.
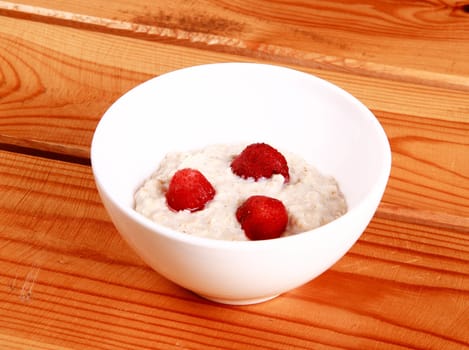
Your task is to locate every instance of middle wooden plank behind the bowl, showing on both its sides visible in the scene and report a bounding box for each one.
[0,16,469,227]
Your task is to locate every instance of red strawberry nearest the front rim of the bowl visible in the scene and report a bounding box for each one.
[236,196,288,240]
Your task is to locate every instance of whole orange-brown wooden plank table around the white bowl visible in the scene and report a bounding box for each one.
[0,0,469,350]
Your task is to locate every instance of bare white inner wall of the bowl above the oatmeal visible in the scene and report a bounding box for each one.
[92,63,390,216]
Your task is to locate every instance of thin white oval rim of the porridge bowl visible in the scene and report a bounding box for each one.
[90,62,392,250]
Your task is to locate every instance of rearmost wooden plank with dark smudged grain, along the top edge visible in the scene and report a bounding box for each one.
[0,0,469,91]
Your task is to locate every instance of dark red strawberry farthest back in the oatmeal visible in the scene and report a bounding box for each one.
[231,143,290,182]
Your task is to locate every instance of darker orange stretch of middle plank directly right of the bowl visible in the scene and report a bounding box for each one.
[377,112,469,230]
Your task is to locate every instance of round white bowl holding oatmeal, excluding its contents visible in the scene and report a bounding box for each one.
[91,63,391,304]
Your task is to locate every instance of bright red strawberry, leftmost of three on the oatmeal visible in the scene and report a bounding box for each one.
[166,168,215,212]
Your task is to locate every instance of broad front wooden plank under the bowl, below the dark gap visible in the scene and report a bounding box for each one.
[0,151,469,350]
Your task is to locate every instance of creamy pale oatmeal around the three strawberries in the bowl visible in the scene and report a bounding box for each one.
[135,145,347,240]
